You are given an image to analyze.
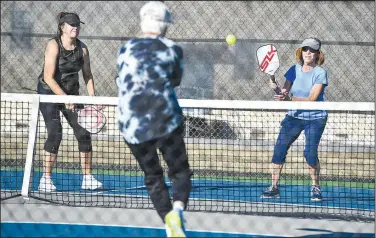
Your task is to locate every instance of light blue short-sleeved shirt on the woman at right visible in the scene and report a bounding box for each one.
[285,64,328,120]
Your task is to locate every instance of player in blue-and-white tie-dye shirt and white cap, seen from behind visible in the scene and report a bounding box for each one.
[117,1,192,237]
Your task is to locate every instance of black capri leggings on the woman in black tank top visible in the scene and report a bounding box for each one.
[39,103,92,154]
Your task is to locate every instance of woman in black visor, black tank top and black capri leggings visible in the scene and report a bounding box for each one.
[37,12,103,192]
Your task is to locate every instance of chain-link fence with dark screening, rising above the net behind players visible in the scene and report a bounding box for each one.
[1,1,375,102]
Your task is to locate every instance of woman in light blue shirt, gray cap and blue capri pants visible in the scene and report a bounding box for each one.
[262,38,328,201]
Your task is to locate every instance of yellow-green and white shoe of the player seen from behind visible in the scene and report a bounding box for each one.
[165,209,186,237]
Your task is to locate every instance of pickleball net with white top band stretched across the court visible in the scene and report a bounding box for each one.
[1,93,375,220]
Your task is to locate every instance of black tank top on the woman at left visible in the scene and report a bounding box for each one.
[37,37,84,95]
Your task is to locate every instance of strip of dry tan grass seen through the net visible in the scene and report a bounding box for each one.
[1,138,375,178]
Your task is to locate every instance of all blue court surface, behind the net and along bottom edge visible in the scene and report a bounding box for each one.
[1,171,375,237]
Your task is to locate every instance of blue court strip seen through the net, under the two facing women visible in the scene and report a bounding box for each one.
[1,171,375,211]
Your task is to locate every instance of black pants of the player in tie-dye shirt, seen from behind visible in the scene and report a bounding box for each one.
[127,125,192,221]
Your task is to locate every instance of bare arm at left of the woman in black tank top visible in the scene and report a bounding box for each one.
[43,40,66,95]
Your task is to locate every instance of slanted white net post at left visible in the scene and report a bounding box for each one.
[21,95,40,200]
